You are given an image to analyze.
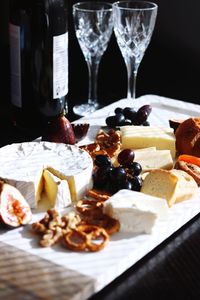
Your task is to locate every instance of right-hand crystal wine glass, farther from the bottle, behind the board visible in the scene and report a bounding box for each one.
[113,0,158,99]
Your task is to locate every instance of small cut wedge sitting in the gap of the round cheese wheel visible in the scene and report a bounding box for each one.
[43,170,71,209]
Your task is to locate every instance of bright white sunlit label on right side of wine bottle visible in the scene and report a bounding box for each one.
[53,32,68,99]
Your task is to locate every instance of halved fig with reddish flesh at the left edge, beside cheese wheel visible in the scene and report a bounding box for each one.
[0,183,32,227]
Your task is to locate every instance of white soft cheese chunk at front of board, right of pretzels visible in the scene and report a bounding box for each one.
[103,190,169,233]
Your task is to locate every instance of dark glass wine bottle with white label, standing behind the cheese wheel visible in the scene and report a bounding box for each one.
[10,0,68,132]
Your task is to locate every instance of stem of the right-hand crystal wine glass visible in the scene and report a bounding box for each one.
[127,61,138,99]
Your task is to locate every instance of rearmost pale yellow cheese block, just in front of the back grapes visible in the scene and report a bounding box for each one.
[120,126,176,158]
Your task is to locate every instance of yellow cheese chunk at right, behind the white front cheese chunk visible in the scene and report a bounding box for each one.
[141,169,198,207]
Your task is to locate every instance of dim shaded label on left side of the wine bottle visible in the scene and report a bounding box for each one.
[9,24,22,108]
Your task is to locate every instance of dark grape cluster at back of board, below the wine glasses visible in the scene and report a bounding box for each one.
[105,105,152,128]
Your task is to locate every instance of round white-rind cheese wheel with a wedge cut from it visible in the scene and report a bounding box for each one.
[0,142,93,208]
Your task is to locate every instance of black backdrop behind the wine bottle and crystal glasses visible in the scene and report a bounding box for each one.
[0,0,200,121]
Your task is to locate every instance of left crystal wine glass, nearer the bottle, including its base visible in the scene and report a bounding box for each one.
[73,1,113,116]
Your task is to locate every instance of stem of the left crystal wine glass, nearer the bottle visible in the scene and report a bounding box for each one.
[87,58,99,106]
